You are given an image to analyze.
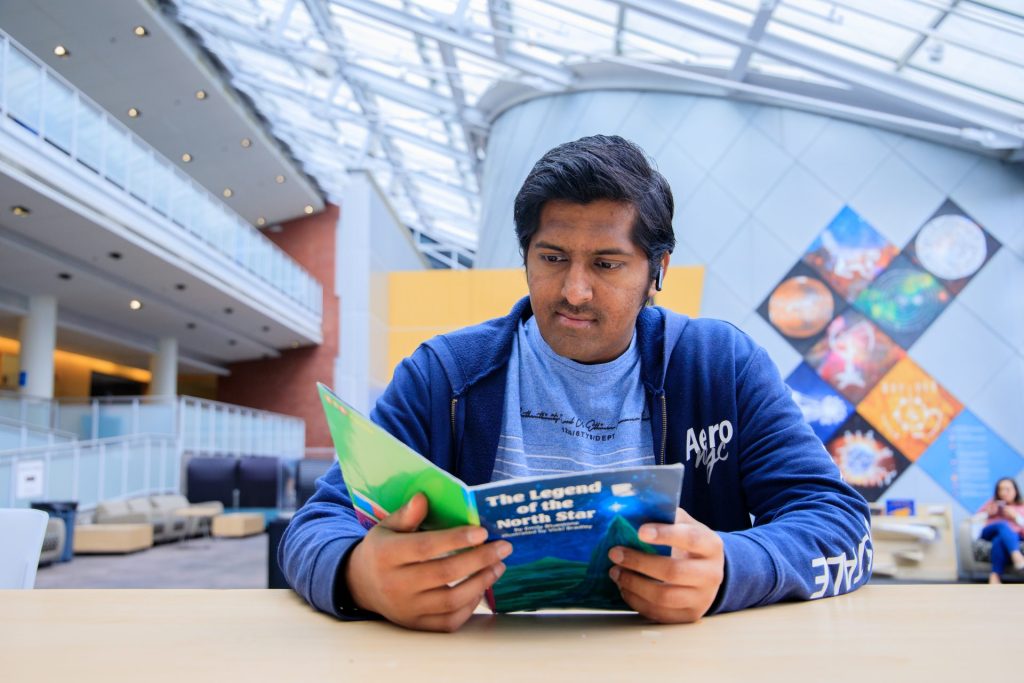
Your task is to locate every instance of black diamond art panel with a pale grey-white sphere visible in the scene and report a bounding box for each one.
[903,200,1001,296]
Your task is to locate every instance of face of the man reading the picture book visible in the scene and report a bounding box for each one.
[526,200,669,364]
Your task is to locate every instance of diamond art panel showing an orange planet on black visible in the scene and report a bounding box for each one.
[758,263,847,353]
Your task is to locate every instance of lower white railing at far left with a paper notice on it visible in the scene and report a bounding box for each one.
[0,434,181,510]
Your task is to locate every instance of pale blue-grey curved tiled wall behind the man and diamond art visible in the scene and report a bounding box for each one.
[476,91,1024,528]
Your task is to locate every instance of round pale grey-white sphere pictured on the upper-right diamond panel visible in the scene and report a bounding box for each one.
[913,214,988,280]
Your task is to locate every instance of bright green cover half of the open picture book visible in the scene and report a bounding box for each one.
[316,383,480,529]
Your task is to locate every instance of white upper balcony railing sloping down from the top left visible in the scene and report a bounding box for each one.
[0,31,323,318]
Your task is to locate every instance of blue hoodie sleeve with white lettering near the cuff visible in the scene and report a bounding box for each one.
[714,346,873,612]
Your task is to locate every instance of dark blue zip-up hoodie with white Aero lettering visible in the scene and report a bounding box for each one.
[279,297,872,616]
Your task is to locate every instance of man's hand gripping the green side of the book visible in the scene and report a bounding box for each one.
[344,494,512,632]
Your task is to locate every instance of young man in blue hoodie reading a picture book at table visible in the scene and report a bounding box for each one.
[279,135,871,631]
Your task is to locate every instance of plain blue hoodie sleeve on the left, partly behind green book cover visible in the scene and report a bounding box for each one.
[278,349,429,618]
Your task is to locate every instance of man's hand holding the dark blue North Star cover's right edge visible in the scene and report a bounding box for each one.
[608,509,725,624]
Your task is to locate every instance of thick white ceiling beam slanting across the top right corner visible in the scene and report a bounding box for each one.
[613,0,1024,143]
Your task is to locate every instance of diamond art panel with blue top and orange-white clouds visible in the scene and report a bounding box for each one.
[803,207,899,301]
